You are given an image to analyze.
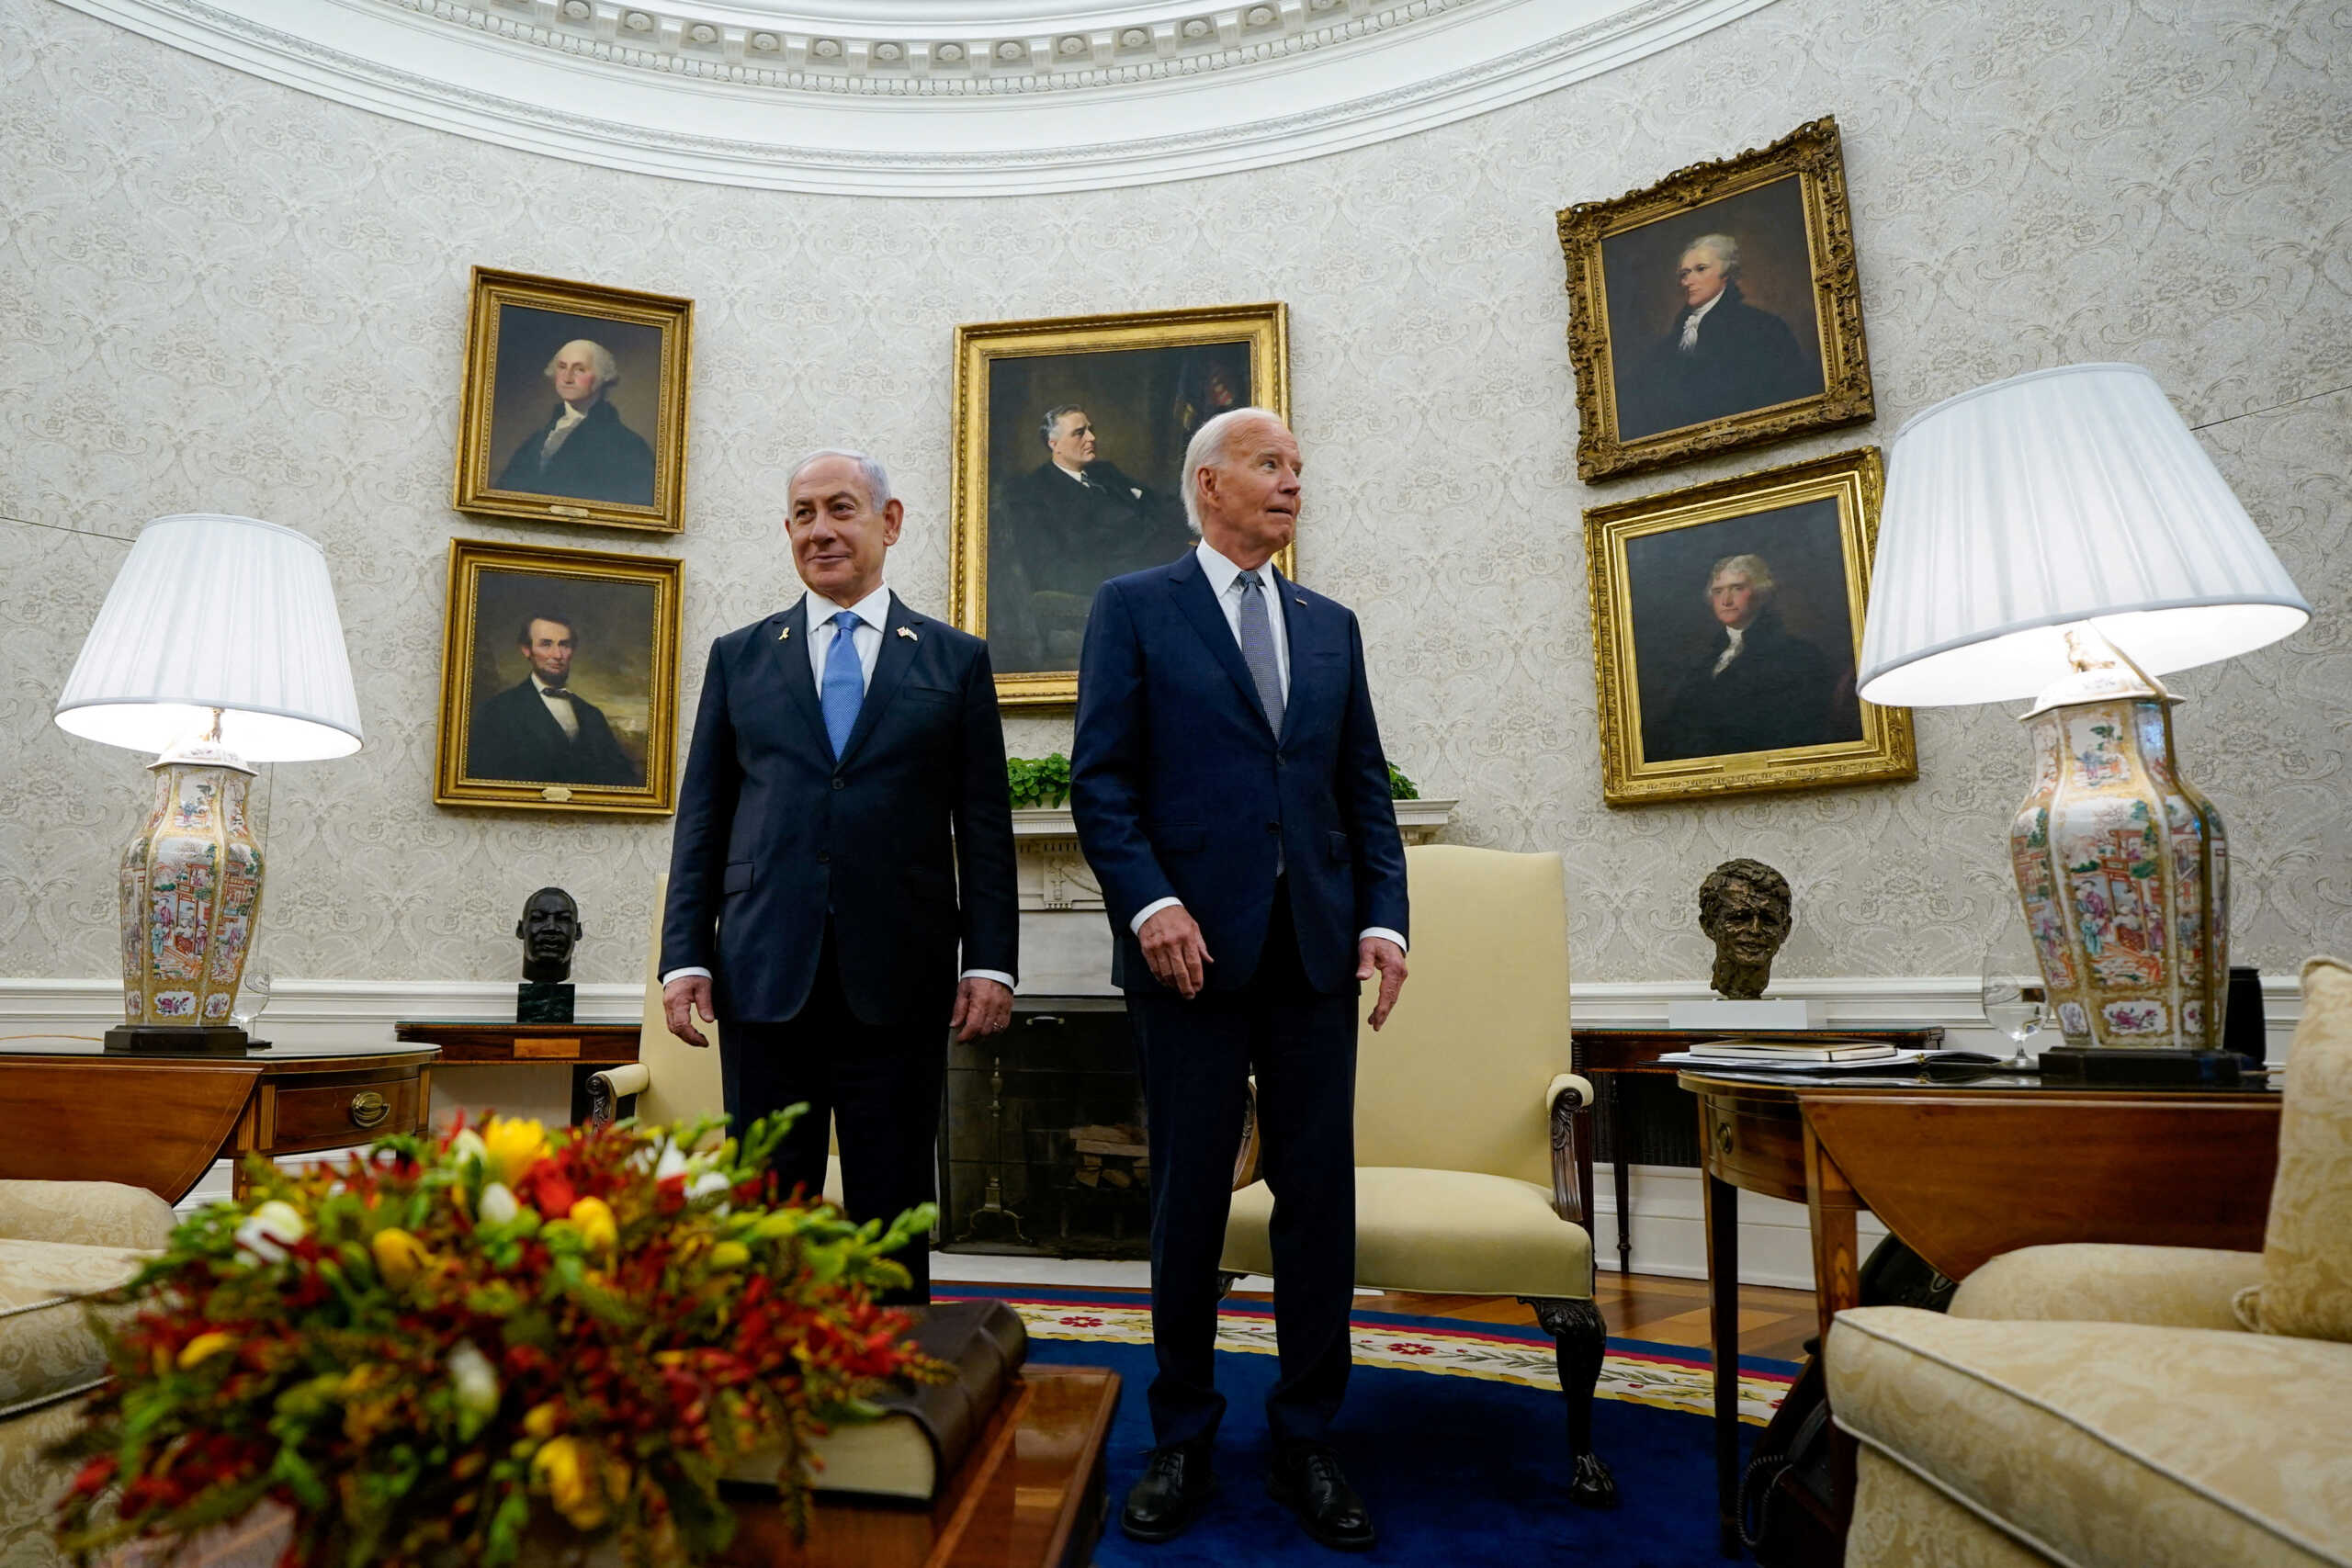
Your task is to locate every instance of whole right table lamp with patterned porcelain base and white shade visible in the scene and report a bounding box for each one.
[1860,365,2312,1084]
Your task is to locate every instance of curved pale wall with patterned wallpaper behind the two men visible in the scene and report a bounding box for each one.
[0,0,2352,983]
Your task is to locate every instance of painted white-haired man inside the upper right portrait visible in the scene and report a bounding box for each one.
[1618,235,1823,440]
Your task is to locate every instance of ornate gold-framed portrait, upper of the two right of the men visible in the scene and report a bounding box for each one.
[1559,115,1874,479]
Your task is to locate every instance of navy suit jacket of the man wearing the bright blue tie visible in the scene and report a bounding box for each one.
[659,594,1021,1030]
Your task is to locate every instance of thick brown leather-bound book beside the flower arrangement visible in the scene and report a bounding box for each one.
[727,1300,1028,1502]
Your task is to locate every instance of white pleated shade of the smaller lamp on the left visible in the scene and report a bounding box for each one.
[56,513,360,761]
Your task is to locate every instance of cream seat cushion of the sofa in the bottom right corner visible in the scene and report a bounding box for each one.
[1827,1307,2352,1568]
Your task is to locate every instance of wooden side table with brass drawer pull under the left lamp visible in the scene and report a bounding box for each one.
[0,1042,435,1203]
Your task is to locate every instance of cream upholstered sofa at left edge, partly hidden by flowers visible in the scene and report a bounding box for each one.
[0,1180,172,1568]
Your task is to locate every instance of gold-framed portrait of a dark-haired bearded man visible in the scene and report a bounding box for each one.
[433,538,682,816]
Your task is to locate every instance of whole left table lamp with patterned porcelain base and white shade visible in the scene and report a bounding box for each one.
[54,514,360,1055]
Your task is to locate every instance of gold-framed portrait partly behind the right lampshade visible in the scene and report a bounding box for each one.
[1585,446,1919,807]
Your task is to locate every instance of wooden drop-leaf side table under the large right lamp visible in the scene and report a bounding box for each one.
[1679,1067,2279,1556]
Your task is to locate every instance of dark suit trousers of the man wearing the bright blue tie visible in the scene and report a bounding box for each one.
[719,924,948,1303]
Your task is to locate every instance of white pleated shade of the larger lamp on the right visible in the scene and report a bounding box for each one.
[1860,365,2312,707]
